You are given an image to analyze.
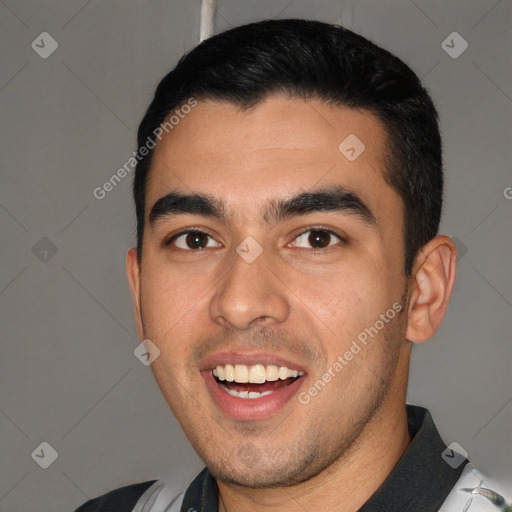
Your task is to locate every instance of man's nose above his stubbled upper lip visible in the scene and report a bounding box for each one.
[210,242,290,329]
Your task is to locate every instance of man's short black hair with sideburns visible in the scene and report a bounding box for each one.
[133,19,443,275]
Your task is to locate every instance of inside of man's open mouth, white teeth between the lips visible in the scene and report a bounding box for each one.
[212,364,304,400]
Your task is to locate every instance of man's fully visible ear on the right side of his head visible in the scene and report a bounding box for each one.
[406,235,457,343]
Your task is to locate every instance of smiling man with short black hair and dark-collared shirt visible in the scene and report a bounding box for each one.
[78,20,506,512]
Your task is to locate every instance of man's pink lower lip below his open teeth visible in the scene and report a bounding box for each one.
[202,372,303,421]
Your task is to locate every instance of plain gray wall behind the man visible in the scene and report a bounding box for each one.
[0,0,512,512]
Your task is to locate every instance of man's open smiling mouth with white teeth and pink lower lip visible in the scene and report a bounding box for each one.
[201,355,307,421]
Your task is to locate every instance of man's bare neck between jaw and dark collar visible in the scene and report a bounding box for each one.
[218,396,411,512]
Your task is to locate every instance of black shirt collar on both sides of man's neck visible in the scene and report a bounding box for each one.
[181,405,468,512]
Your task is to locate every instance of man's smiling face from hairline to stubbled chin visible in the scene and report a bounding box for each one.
[128,96,412,487]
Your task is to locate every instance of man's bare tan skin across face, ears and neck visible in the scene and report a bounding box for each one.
[127,96,456,512]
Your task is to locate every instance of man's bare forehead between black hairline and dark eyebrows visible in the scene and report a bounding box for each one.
[146,95,400,226]
